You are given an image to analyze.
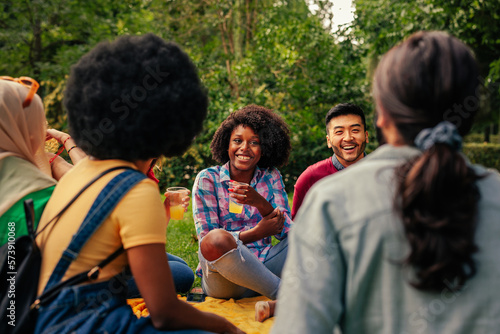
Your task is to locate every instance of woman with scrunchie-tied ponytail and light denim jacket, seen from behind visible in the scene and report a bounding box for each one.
[272,32,500,334]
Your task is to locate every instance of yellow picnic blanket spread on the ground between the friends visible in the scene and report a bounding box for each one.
[128,296,274,334]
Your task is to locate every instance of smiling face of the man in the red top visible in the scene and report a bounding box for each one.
[326,115,368,167]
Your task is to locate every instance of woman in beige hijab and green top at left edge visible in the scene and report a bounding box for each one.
[0,77,85,245]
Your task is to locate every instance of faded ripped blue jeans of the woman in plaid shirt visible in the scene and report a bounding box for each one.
[198,238,288,300]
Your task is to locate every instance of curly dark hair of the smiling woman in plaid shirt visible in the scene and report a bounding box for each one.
[210,104,291,168]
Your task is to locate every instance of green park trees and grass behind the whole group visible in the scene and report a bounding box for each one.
[0,0,500,285]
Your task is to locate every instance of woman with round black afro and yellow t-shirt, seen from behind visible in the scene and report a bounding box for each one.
[35,34,242,334]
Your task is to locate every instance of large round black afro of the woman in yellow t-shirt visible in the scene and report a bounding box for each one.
[64,34,208,161]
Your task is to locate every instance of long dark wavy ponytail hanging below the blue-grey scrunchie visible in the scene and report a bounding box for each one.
[395,144,480,291]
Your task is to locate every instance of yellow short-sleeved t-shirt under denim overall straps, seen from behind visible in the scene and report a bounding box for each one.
[37,158,167,293]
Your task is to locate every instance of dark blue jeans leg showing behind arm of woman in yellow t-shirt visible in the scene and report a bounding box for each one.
[127,253,194,298]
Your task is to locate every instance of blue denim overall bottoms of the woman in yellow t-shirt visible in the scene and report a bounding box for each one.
[35,278,214,334]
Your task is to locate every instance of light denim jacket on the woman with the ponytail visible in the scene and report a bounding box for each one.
[272,145,500,334]
